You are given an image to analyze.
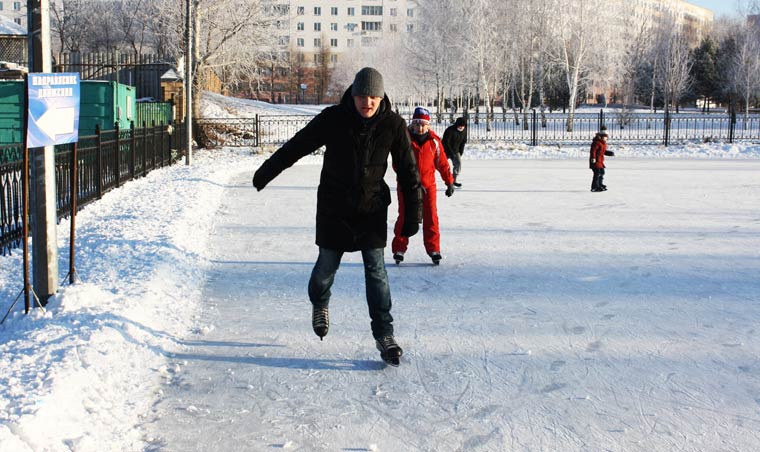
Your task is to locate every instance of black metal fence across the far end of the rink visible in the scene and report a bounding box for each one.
[198,110,760,147]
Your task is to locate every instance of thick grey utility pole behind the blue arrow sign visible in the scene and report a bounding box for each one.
[24,0,58,305]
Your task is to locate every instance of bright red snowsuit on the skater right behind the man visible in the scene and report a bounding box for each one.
[391,129,454,254]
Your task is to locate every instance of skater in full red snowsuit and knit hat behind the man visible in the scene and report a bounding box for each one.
[391,107,454,265]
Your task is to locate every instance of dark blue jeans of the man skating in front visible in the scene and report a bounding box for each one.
[309,247,393,339]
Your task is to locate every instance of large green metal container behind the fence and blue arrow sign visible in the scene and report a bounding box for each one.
[0,80,137,145]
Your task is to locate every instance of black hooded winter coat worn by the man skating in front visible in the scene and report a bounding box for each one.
[253,87,422,251]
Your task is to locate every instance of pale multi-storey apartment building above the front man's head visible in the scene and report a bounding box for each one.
[271,0,418,66]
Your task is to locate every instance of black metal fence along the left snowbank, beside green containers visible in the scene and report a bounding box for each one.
[0,124,186,255]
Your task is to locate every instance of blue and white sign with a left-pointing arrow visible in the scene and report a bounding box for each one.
[26,72,80,148]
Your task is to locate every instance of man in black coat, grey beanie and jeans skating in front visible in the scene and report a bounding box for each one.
[253,68,422,362]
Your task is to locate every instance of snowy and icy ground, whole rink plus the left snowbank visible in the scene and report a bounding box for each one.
[0,93,760,452]
